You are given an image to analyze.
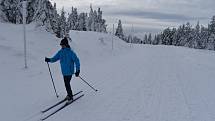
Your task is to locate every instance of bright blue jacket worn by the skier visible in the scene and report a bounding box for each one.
[50,48,80,76]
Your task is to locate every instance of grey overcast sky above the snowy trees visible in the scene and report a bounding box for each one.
[51,0,215,33]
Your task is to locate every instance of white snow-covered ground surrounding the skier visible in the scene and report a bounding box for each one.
[0,23,215,121]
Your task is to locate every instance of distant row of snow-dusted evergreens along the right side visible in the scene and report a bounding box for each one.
[116,16,215,50]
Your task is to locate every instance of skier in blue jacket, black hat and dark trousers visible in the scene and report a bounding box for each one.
[45,37,80,101]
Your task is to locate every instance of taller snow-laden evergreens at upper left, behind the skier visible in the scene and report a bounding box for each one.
[0,0,107,38]
